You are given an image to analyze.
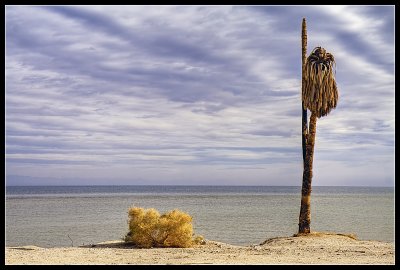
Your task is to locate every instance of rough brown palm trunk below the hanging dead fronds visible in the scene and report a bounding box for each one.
[299,113,317,233]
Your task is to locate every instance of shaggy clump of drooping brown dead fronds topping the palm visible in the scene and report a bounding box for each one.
[302,47,339,118]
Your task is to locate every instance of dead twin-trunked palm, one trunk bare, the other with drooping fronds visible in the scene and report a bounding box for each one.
[299,19,339,233]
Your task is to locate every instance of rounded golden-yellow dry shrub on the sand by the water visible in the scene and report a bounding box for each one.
[125,207,204,248]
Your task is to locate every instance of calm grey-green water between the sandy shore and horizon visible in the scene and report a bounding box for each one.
[6,186,394,247]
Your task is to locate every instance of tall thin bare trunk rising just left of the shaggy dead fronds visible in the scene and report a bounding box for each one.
[301,18,307,166]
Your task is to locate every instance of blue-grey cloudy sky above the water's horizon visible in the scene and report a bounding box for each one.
[5,6,395,186]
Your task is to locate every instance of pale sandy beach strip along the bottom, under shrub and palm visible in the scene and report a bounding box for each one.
[5,233,395,265]
